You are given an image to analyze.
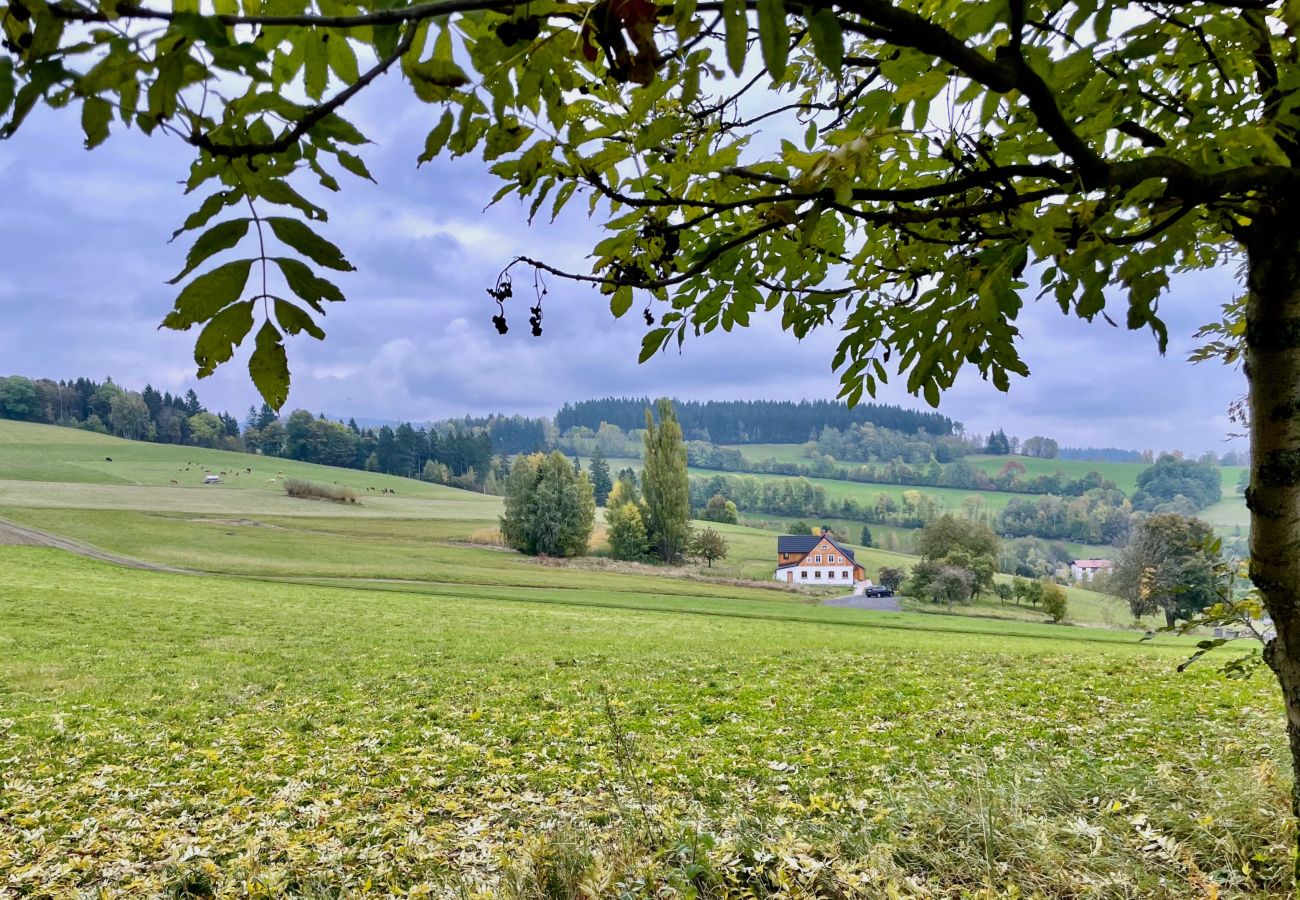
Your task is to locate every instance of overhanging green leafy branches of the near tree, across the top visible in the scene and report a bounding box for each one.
[0,0,1284,406]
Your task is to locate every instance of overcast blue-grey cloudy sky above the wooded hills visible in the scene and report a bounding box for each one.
[0,75,1245,453]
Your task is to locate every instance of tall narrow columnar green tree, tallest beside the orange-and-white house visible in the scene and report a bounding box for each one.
[641,398,690,562]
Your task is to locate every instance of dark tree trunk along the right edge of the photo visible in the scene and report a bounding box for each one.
[1245,223,1300,877]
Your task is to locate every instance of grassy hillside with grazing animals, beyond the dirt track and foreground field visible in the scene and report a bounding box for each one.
[0,421,1126,626]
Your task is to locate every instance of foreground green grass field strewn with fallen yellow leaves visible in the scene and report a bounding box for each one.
[0,543,1290,900]
